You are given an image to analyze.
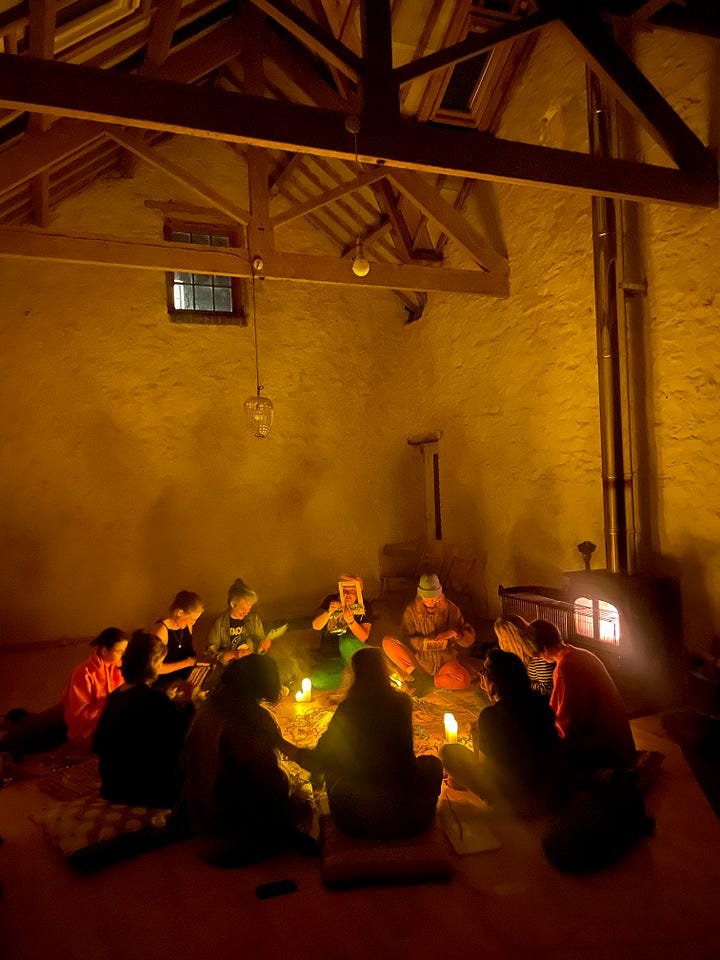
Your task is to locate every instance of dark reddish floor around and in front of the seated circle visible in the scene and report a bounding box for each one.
[0,620,720,960]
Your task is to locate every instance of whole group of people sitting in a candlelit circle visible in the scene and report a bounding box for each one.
[1,574,635,866]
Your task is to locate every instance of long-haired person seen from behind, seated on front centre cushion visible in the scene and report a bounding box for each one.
[291,647,442,839]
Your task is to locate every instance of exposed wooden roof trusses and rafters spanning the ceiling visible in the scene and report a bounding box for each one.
[0,0,718,319]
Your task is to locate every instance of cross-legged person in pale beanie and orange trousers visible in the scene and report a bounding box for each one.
[382,573,475,697]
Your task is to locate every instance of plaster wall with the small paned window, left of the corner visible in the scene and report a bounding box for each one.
[0,140,422,643]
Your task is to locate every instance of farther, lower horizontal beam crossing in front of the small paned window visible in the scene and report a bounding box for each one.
[0,227,509,297]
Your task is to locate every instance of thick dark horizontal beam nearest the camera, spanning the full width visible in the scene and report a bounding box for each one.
[0,54,718,207]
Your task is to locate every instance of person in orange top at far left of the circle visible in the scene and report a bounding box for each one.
[63,627,127,746]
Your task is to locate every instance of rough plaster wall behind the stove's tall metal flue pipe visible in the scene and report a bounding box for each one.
[388,22,720,652]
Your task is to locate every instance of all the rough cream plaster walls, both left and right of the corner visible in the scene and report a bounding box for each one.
[0,24,720,645]
